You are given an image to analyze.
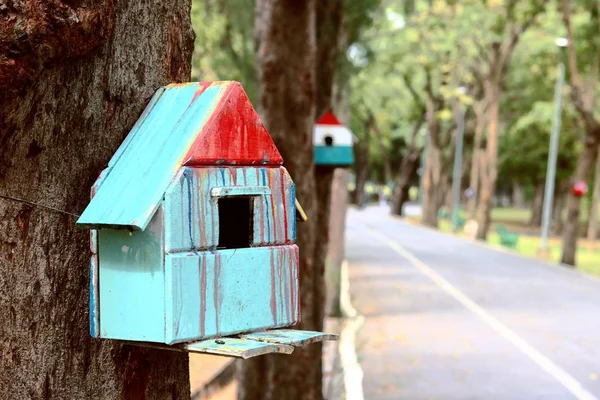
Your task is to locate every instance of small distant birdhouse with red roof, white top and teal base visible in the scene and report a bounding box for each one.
[313,111,354,167]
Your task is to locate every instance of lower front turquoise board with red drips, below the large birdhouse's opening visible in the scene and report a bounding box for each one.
[165,245,300,344]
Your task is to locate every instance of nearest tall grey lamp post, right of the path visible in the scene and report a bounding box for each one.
[539,38,569,256]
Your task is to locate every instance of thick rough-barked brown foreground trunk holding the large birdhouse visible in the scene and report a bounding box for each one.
[0,0,193,399]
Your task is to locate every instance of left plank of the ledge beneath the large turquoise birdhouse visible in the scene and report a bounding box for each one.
[184,338,294,359]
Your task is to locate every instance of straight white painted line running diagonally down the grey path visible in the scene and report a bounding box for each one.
[367,226,598,400]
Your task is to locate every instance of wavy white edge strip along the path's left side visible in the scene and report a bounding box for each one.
[339,261,364,400]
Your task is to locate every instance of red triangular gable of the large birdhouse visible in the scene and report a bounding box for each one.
[184,82,283,166]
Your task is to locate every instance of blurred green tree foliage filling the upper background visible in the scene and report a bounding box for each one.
[192,0,600,195]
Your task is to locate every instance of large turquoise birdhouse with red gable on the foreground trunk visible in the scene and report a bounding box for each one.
[77,82,336,358]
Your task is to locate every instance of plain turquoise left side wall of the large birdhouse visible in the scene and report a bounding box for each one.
[98,209,165,342]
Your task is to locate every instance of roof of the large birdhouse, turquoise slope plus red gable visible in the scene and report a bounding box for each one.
[77,81,283,230]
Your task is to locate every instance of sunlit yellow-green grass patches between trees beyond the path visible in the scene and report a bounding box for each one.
[424,208,600,275]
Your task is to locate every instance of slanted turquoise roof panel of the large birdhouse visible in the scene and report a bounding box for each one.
[77,84,226,230]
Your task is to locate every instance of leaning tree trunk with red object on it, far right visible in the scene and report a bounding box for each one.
[561,137,598,266]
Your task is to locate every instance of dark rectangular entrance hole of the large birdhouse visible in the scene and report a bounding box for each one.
[218,196,254,249]
